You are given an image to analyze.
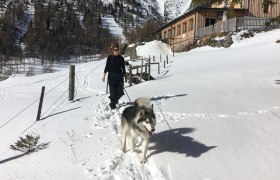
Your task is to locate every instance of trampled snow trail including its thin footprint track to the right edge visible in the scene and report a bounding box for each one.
[70,59,280,180]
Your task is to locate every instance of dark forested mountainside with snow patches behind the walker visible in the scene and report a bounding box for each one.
[0,0,162,61]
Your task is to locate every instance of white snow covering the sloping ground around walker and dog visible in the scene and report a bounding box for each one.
[0,30,280,180]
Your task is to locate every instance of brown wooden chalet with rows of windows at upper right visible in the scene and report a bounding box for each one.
[155,0,280,51]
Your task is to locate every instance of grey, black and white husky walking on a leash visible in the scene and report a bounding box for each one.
[121,98,156,163]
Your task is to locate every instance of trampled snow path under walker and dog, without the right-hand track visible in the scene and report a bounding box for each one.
[68,58,169,180]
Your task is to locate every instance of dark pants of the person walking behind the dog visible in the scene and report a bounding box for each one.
[108,74,124,109]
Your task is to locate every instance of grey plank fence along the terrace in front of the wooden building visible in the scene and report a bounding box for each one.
[196,16,280,37]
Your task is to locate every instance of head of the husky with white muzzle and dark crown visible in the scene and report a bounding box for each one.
[138,105,156,136]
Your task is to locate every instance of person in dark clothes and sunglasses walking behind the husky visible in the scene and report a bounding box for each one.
[102,44,126,109]
